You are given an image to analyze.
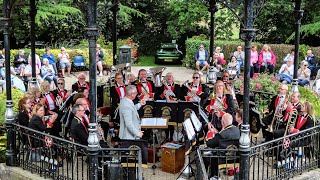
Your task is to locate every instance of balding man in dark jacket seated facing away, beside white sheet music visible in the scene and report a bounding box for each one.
[206,113,240,177]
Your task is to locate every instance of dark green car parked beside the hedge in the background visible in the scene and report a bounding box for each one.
[155,43,183,64]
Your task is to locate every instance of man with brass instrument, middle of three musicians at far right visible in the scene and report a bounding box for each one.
[273,92,301,139]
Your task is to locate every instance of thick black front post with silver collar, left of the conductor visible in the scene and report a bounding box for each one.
[86,0,99,180]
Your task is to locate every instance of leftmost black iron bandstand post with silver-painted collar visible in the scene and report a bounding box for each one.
[0,0,16,166]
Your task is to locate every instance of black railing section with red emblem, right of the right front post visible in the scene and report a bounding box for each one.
[250,126,320,179]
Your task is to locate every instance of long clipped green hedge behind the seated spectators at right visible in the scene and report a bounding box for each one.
[183,35,320,69]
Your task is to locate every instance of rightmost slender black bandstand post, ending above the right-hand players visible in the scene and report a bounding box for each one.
[292,0,303,92]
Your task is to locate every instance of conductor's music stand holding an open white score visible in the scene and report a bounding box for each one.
[141,117,168,175]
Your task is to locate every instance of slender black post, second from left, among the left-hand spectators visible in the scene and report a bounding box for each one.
[28,0,37,88]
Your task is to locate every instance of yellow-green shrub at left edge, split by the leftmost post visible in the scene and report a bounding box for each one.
[0,88,24,124]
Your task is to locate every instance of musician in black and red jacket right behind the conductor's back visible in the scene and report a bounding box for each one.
[110,72,126,146]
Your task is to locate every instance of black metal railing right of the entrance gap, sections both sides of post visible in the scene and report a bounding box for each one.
[196,125,320,180]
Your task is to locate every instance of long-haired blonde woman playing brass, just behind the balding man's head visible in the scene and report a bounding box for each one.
[206,80,235,130]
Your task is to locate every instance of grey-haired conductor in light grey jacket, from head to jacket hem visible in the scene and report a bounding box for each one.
[119,85,146,140]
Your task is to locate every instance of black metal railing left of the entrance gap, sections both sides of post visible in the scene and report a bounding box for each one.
[13,123,142,180]
